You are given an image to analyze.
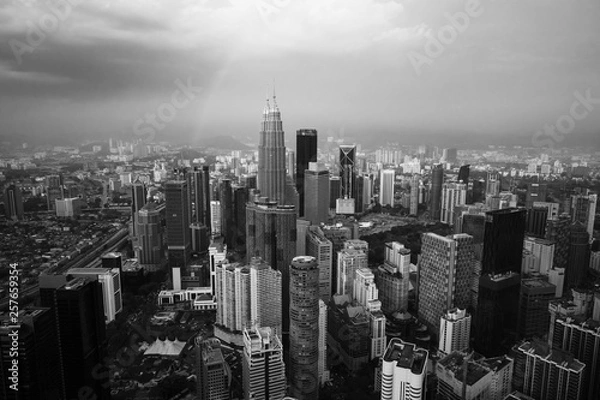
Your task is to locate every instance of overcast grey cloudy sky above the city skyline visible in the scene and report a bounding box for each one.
[0,0,600,148]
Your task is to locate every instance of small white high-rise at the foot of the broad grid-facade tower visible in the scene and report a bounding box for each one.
[438,308,471,354]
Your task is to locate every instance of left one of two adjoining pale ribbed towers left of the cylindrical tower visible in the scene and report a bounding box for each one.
[215,263,252,332]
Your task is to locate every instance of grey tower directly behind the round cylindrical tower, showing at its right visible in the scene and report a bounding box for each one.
[306,226,333,303]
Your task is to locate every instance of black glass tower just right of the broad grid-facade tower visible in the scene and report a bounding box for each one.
[482,208,526,274]
